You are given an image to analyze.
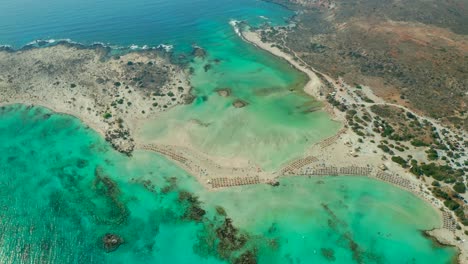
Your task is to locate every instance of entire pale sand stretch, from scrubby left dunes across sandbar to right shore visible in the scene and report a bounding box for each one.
[0,31,468,262]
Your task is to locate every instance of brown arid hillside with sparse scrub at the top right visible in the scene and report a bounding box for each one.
[264,0,468,130]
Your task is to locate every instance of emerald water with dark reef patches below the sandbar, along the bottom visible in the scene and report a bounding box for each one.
[0,105,455,263]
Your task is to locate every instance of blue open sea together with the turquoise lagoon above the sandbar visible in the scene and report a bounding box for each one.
[0,0,340,170]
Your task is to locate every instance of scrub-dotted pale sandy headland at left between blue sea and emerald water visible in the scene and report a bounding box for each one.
[0,43,191,154]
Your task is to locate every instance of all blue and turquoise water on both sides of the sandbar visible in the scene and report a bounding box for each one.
[0,0,455,263]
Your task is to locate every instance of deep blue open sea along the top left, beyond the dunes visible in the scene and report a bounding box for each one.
[0,0,292,50]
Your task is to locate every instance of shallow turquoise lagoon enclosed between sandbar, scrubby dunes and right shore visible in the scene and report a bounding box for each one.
[139,42,340,170]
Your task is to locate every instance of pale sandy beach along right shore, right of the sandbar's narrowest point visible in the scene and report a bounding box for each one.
[239,26,468,263]
